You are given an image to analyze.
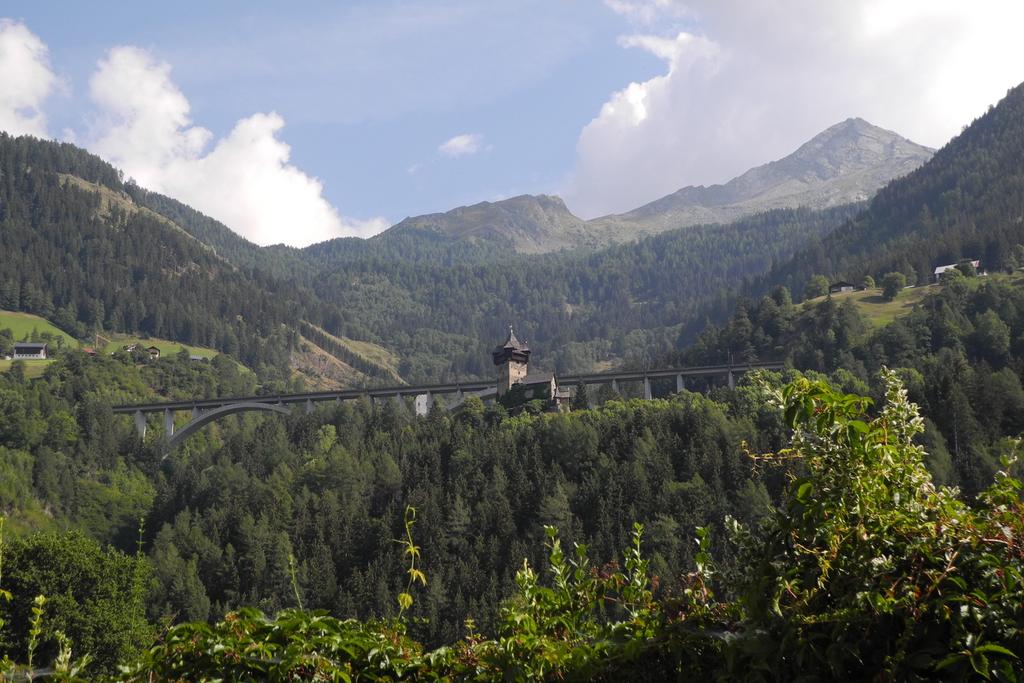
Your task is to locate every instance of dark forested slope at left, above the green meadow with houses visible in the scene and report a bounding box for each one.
[0,134,315,378]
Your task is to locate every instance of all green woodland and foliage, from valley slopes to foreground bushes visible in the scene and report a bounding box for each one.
[0,48,1024,681]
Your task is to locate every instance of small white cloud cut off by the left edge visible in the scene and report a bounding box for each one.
[0,19,58,137]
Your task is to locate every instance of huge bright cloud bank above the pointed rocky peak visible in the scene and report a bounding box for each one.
[564,0,1024,217]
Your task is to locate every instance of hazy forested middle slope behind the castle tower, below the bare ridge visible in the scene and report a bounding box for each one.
[307,206,858,381]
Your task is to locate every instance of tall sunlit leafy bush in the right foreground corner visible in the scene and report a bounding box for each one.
[735,373,1024,681]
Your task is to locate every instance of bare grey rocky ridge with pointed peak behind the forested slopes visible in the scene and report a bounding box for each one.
[385,119,934,253]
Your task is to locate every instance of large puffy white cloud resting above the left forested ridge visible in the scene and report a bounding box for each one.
[88,47,388,246]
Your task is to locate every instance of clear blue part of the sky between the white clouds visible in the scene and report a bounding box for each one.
[4,0,662,229]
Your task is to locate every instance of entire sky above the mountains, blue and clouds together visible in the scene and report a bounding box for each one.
[0,0,1024,244]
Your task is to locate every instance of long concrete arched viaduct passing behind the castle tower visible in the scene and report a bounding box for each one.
[113,362,784,450]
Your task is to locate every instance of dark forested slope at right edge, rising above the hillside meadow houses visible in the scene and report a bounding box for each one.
[760,85,1024,292]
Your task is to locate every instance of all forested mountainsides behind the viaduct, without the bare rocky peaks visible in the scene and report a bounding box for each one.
[0,80,1024,382]
